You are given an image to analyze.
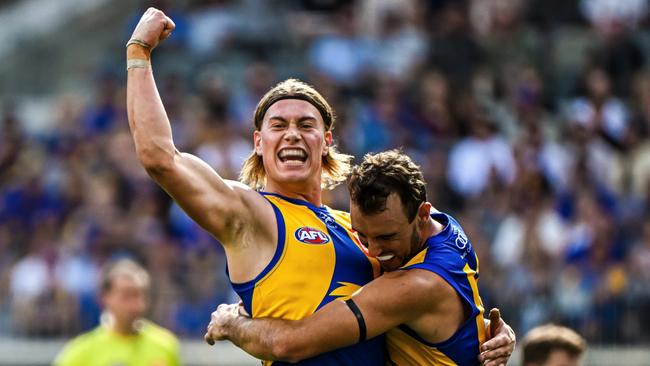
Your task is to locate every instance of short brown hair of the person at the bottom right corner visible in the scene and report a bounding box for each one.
[522,324,587,366]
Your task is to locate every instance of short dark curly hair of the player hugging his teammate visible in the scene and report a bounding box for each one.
[348,149,427,222]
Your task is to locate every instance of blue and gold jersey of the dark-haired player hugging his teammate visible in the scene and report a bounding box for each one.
[387,213,485,366]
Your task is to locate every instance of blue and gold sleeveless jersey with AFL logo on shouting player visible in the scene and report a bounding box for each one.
[232,193,386,365]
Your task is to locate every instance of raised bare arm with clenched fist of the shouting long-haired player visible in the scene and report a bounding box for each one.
[127,8,264,245]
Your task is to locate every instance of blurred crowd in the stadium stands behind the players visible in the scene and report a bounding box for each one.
[0,0,650,365]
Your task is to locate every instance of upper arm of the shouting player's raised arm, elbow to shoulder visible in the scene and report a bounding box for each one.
[149,152,251,245]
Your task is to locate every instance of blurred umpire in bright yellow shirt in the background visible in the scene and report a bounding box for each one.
[54,259,180,366]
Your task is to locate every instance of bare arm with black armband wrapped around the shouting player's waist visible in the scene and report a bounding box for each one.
[205,271,437,362]
